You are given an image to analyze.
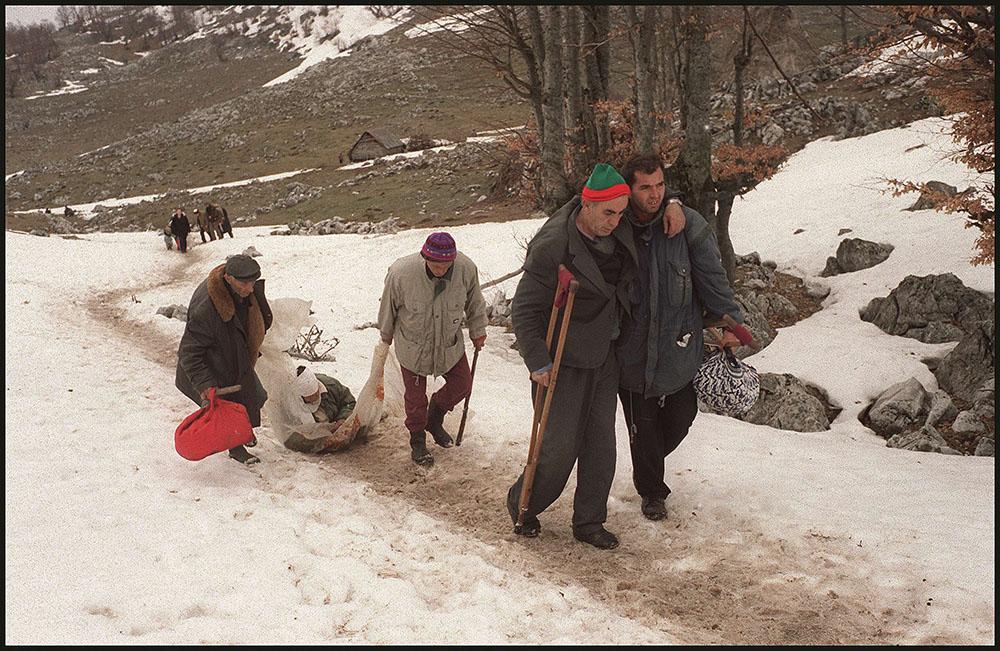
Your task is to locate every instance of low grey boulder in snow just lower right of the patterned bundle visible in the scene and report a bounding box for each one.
[743,373,830,432]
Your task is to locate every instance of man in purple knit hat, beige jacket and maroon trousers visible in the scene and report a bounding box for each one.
[378,232,487,466]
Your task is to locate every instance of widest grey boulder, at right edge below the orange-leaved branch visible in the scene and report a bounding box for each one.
[861,273,993,343]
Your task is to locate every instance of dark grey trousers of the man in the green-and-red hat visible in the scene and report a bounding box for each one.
[507,346,618,534]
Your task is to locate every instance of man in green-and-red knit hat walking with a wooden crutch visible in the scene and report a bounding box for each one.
[507,163,637,549]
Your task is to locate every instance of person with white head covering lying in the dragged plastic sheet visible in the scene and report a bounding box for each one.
[285,366,357,453]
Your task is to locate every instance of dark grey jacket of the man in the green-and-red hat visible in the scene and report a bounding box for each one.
[511,196,637,372]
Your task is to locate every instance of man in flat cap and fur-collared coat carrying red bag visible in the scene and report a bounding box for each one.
[175,255,273,464]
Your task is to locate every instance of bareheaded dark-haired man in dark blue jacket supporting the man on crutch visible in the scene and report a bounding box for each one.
[617,154,750,520]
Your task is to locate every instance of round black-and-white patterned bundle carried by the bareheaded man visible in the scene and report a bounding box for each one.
[694,348,760,418]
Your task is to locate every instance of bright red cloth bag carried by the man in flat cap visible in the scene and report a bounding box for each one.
[174,388,253,461]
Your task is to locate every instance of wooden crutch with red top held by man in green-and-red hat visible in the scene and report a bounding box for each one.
[514,265,580,533]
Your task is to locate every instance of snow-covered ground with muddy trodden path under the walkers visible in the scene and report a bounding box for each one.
[5,118,994,644]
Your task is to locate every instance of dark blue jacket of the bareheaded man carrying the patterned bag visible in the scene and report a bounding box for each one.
[617,207,743,397]
